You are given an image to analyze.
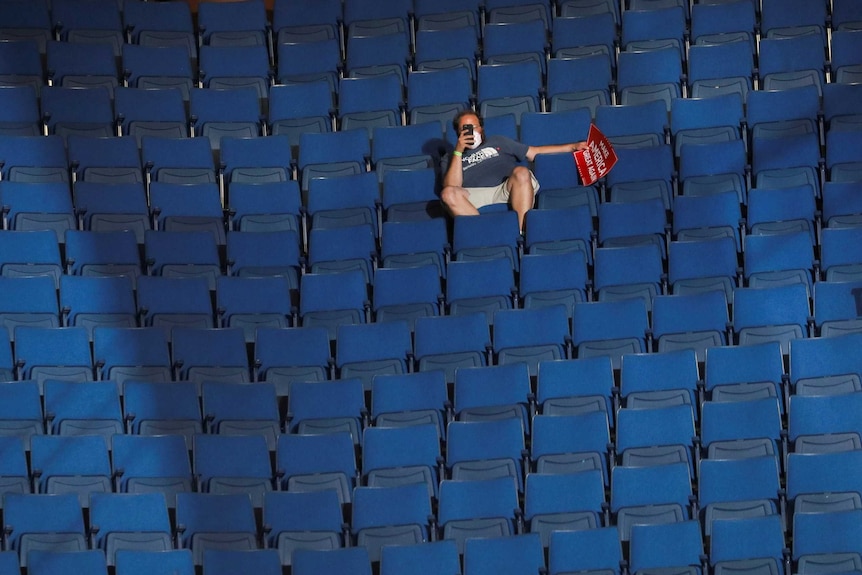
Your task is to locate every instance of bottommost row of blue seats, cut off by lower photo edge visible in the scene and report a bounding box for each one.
[0,512,859,575]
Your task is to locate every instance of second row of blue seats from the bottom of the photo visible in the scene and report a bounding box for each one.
[4,436,860,572]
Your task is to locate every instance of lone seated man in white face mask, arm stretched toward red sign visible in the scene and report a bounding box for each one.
[441,110,587,230]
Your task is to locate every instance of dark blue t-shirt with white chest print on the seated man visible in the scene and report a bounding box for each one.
[444,136,529,188]
